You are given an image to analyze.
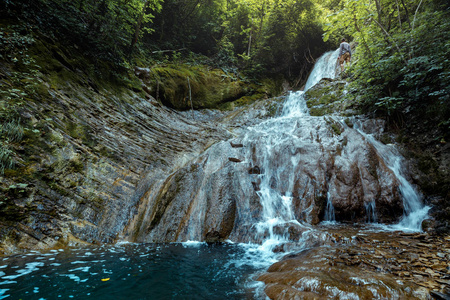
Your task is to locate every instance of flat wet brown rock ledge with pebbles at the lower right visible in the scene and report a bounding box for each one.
[258,225,450,299]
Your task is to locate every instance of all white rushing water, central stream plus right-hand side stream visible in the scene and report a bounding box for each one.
[243,45,429,259]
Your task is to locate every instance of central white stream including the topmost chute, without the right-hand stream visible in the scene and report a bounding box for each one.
[239,51,338,263]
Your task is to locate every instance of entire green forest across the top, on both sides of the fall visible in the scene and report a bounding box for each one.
[0,0,450,108]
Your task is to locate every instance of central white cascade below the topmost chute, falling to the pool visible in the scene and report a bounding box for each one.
[243,102,309,252]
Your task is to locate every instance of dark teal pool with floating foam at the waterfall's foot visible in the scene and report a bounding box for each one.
[0,242,271,299]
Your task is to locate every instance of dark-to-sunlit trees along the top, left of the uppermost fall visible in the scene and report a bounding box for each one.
[0,0,327,82]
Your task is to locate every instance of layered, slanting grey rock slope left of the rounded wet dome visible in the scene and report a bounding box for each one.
[0,58,234,252]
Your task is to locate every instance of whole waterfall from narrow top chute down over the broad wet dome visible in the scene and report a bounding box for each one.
[129,47,429,248]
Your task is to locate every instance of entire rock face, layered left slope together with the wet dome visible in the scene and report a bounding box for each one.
[0,34,434,253]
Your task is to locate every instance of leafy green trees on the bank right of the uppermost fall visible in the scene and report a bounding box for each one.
[324,0,450,131]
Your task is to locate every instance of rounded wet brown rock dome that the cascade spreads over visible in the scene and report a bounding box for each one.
[125,110,403,242]
